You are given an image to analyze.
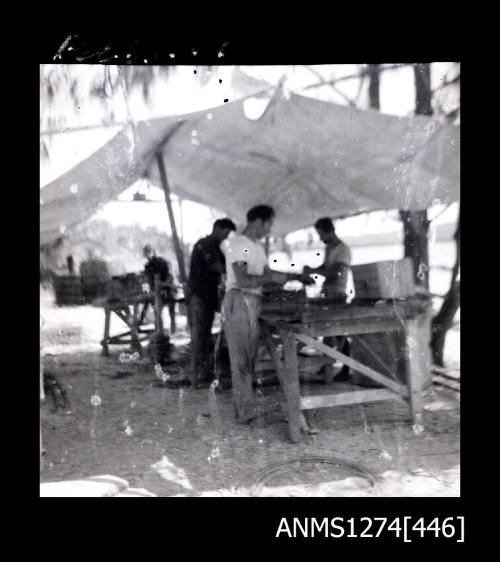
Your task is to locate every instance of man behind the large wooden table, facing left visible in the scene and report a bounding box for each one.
[304,217,351,381]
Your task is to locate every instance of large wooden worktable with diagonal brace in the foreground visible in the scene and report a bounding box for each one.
[260,297,430,443]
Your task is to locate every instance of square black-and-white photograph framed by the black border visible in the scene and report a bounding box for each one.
[39,43,461,506]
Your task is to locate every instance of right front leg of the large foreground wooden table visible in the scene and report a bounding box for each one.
[405,318,425,425]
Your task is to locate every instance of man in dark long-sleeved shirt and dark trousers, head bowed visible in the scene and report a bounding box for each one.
[188,219,236,388]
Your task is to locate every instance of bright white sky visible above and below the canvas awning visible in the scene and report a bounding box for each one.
[40,63,458,243]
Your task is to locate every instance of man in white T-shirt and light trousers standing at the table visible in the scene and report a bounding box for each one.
[222,205,314,425]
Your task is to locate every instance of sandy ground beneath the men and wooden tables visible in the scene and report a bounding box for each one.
[40,291,460,496]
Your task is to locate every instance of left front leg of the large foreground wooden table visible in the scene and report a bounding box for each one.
[281,331,302,443]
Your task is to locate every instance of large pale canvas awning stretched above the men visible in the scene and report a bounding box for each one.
[40,89,460,243]
